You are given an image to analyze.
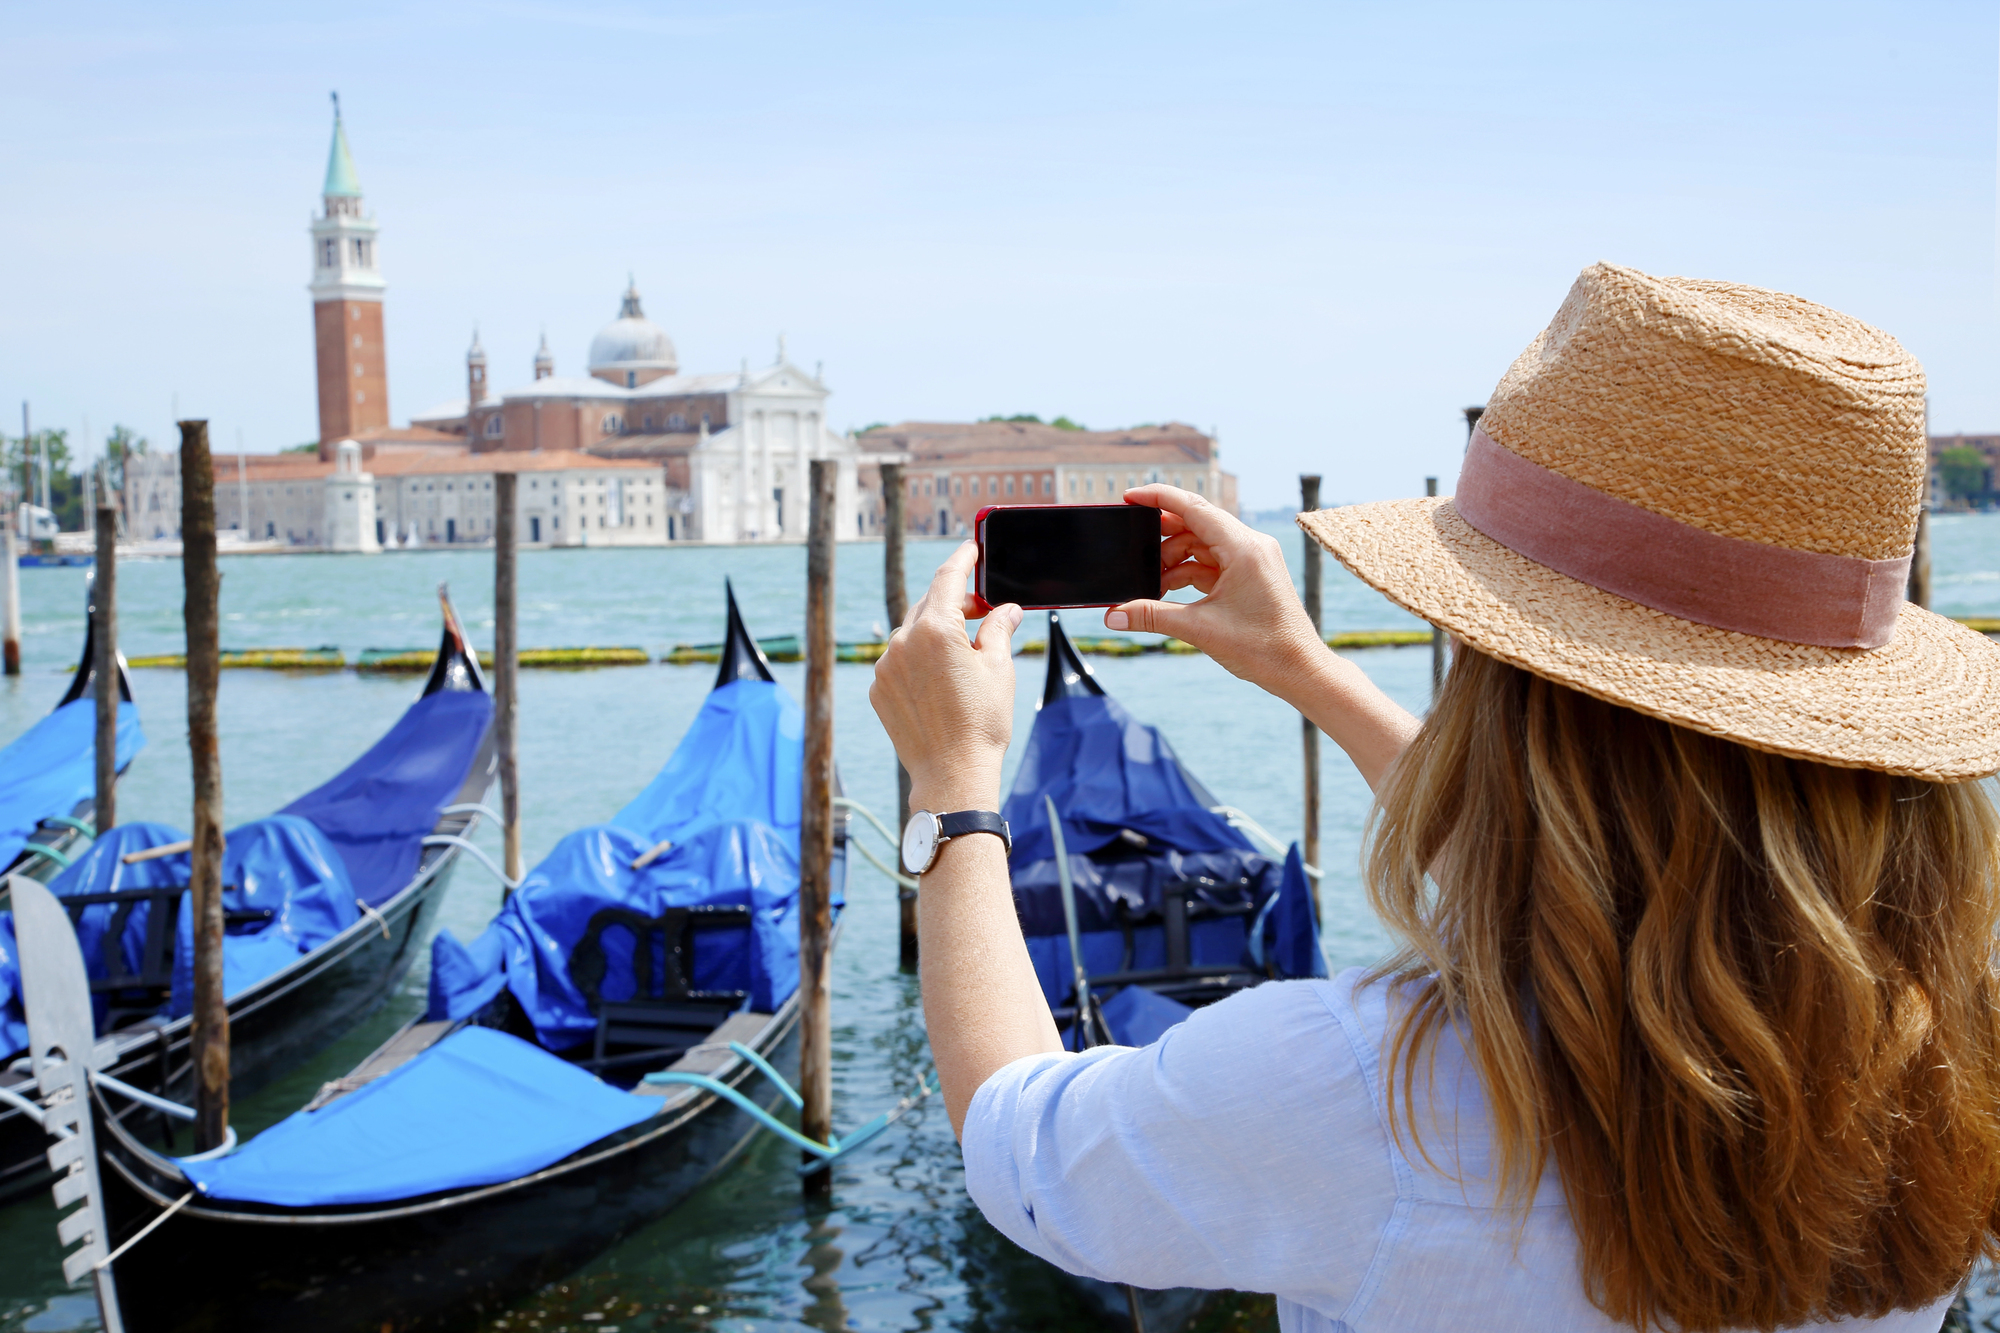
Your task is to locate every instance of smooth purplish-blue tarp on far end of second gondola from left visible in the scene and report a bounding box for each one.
[280,691,494,907]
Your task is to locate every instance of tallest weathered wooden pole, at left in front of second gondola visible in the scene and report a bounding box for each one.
[180,420,230,1153]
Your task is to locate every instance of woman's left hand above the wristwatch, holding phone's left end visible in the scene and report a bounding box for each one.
[868,542,1022,815]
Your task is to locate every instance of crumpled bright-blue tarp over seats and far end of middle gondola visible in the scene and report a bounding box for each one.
[430,681,838,1051]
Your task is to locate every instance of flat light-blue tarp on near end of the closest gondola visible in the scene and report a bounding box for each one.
[180,1027,660,1207]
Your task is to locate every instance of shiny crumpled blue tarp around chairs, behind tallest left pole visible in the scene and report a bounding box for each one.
[0,815,360,1051]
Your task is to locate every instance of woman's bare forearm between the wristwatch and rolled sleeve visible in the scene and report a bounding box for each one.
[912,793,1062,1135]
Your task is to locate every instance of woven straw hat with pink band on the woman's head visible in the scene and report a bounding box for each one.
[1298,264,2000,783]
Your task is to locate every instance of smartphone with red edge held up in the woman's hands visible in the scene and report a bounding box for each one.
[972,504,1160,610]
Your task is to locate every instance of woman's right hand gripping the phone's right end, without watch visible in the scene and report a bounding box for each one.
[1104,484,1328,699]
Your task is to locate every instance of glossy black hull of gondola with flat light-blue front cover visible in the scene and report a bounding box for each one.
[100,997,798,1333]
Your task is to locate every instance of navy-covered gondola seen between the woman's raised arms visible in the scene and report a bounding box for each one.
[1002,612,1326,1333]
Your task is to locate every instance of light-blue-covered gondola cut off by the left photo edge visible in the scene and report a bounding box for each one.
[0,576,146,880]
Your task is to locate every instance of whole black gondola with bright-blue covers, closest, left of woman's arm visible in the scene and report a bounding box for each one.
[39,596,846,1331]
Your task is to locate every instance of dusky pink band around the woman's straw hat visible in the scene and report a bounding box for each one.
[1452,430,1910,648]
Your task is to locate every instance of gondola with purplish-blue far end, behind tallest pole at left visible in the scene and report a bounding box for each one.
[0,588,494,1195]
